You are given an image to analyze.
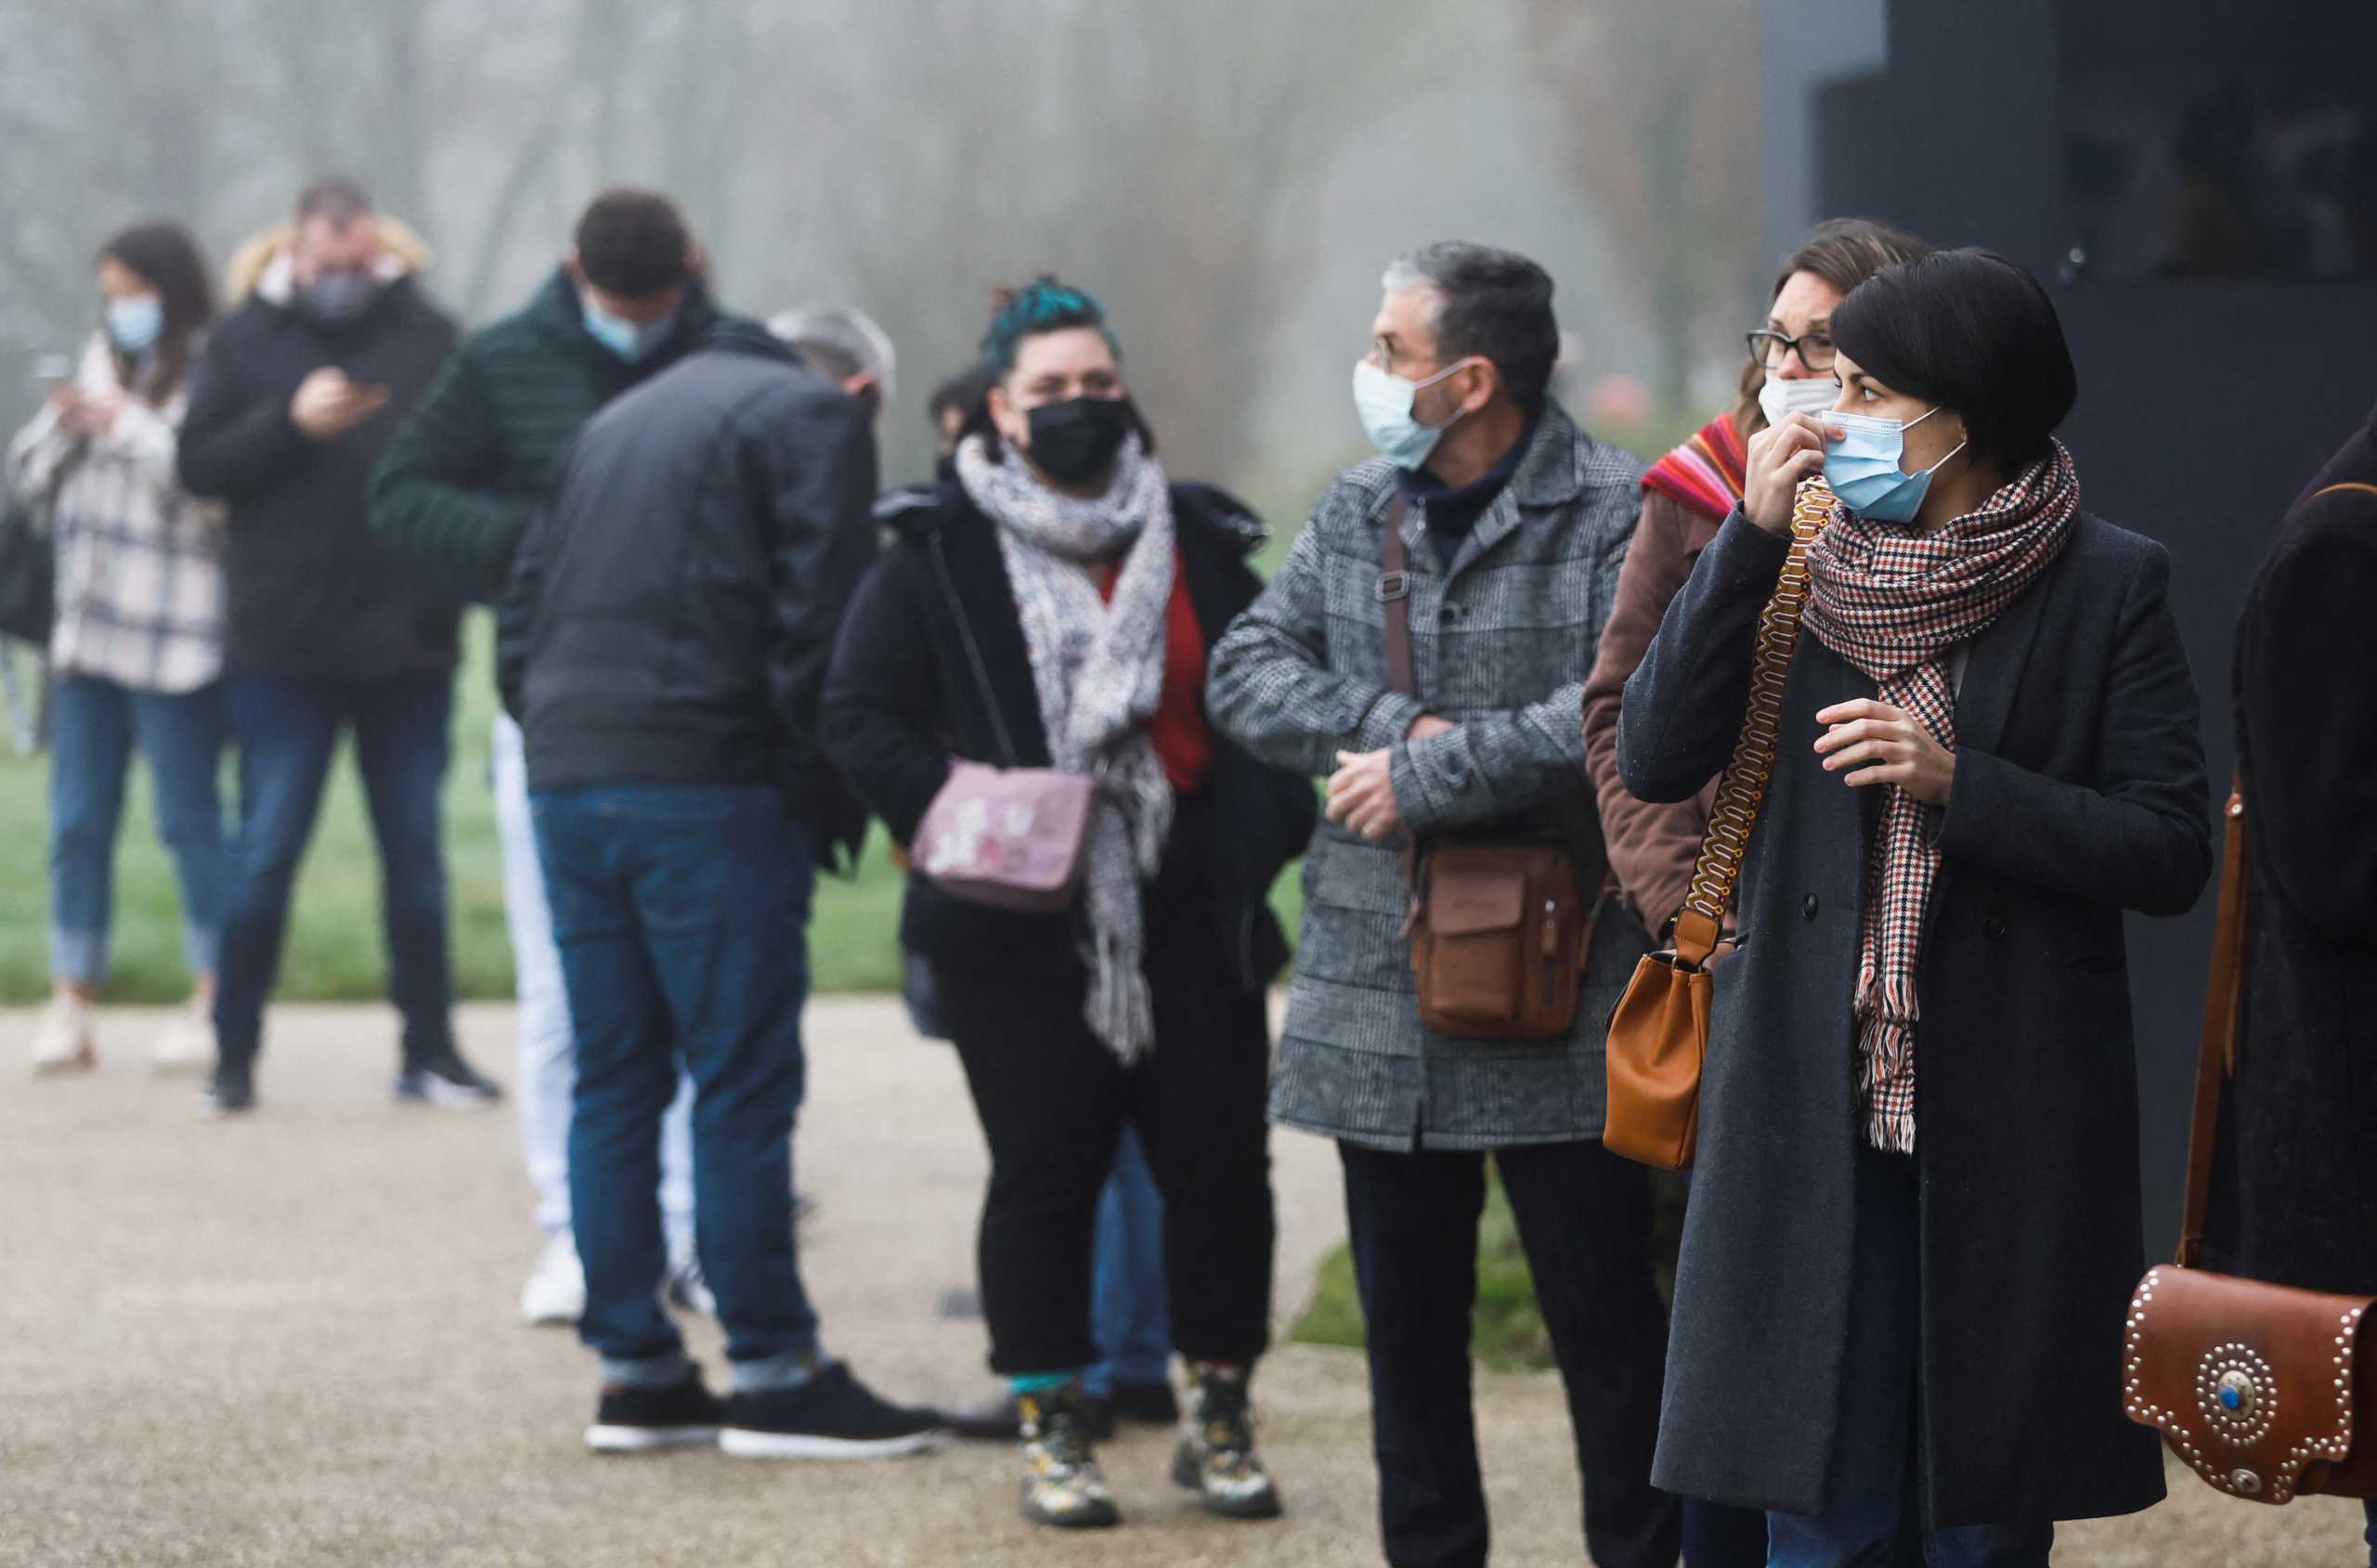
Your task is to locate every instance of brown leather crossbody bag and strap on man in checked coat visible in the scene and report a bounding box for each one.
[1379,492,1592,1041]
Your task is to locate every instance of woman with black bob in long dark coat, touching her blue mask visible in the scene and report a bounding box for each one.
[1618,252,2211,1568]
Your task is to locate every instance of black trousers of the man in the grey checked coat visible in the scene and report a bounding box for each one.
[1338,1143,1766,1568]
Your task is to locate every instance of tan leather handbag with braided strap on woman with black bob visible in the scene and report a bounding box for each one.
[1602,482,1833,1172]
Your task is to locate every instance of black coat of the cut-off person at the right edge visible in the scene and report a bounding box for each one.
[2206,398,2377,1295]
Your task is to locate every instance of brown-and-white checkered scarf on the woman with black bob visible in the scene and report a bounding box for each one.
[1804,442,2080,1155]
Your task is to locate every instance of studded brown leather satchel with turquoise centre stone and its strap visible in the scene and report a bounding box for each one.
[2121,794,2377,1504]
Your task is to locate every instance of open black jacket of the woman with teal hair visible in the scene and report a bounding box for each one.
[825,485,1319,991]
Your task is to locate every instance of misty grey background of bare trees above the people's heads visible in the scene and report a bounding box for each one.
[0,0,1773,515]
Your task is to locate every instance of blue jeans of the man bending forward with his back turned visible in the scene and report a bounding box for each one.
[530,784,818,1390]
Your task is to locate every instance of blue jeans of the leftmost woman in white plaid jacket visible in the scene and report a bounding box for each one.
[50,675,230,986]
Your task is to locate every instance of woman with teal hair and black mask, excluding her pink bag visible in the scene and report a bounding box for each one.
[825,280,1317,1527]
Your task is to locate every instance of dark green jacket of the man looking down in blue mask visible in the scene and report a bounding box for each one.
[366,268,725,601]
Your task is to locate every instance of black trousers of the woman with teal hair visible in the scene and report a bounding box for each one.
[934,803,1274,1376]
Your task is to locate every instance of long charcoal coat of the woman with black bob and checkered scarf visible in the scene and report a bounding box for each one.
[1618,513,2211,1525]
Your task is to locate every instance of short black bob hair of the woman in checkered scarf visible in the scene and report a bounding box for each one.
[1833,247,2080,475]
